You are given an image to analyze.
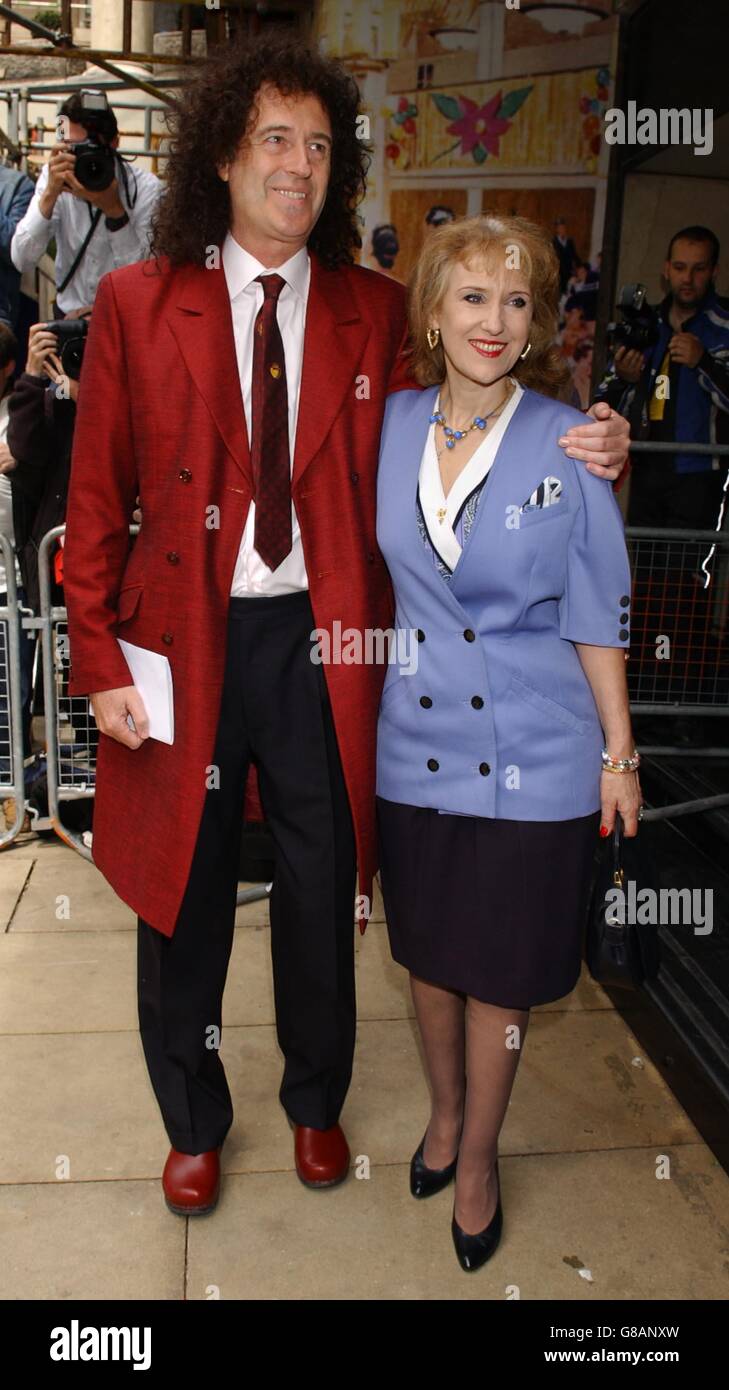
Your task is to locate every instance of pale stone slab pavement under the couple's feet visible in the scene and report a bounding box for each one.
[0,834,729,1301]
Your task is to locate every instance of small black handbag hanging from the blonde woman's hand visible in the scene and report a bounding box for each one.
[584,815,661,990]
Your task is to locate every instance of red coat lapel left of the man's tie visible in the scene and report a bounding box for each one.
[167,265,253,489]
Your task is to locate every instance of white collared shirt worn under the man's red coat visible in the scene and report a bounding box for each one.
[223,232,312,598]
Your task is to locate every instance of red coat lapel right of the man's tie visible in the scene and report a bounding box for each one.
[292,254,370,487]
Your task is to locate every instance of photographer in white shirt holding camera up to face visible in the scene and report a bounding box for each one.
[10,89,163,318]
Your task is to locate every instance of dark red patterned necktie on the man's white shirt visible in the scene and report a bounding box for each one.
[250,275,292,570]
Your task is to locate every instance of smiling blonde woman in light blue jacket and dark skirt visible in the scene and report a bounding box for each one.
[377,217,640,1270]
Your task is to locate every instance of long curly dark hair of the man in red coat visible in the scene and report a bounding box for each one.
[150,35,371,268]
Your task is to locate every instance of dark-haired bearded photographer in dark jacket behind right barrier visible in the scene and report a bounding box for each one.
[597,227,729,530]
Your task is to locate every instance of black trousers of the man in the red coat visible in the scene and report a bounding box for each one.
[138,591,356,1154]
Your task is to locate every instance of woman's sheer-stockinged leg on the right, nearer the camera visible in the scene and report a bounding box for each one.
[455,995,529,1236]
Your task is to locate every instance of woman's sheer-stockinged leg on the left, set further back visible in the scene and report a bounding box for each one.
[410,974,466,1168]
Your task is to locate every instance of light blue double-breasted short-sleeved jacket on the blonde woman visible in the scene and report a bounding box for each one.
[377,386,630,820]
